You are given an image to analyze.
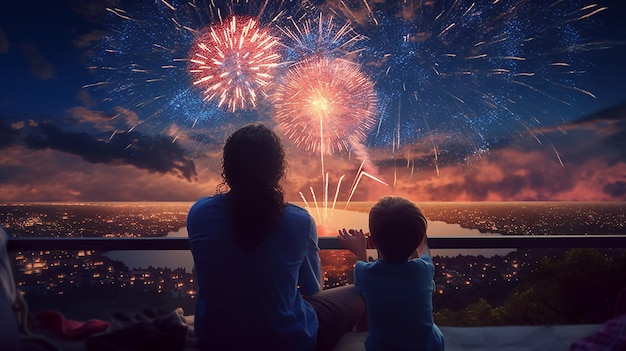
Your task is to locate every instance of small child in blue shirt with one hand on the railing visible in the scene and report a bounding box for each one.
[339,197,444,351]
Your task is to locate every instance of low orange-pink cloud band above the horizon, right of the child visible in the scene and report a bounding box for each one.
[370,149,626,201]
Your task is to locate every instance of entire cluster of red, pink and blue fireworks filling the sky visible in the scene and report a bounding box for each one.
[86,0,614,176]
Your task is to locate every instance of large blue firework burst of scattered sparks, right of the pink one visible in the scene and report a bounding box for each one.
[330,0,611,166]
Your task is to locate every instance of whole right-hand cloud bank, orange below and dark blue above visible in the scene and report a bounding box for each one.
[342,105,626,201]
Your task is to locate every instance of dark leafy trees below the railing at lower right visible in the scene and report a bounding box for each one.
[434,249,626,326]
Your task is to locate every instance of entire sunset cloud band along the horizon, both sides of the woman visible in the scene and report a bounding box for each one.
[0,99,626,201]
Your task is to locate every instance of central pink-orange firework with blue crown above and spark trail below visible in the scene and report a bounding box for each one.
[273,11,388,226]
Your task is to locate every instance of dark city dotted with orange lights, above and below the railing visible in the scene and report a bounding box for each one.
[12,202,625,323]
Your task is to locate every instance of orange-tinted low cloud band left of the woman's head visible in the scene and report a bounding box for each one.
[0,146,217,202]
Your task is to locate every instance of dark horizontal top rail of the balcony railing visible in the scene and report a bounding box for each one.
[7,235,626,252]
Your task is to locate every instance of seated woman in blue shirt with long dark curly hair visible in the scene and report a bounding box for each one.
[187,124,364,350]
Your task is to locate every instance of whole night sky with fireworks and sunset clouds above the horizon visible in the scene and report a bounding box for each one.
[0,0,626,202]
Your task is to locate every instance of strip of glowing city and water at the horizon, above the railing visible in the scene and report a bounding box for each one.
[0,201,626,236]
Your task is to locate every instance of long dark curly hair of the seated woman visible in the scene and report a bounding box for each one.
[218,124,287,248]
